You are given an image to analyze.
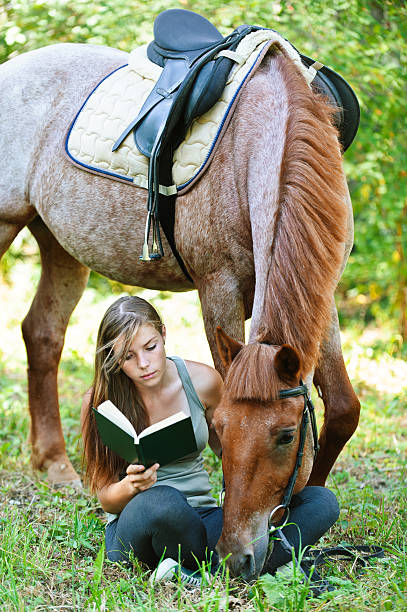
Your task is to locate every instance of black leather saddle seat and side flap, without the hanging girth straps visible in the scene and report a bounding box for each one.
[113,9,252,158]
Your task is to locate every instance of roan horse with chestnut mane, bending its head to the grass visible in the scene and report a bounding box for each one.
[0,38,359,572]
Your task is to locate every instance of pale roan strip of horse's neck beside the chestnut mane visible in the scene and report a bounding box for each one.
[234,57,288,342]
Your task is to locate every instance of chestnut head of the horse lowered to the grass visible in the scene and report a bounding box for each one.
[213,328,313,580]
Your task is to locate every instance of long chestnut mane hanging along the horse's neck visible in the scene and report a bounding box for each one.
[257,55,346,375]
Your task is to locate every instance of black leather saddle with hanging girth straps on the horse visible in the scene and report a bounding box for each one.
[112,9,359,280]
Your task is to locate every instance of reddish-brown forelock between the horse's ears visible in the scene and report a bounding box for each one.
[225,342,281,402]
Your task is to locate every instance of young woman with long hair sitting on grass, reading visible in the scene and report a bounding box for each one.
[81,296,338,584]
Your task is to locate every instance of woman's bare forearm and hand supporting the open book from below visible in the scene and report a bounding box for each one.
[97,463,160,514]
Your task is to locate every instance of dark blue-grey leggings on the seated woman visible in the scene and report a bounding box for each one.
[106,485,339,572]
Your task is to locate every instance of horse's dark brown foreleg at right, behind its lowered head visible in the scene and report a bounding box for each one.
[307,308,360,485]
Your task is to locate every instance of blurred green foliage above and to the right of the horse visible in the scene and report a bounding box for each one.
[0,0,407,339]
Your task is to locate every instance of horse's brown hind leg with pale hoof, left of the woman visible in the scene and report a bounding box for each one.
[22,217,89,484]
